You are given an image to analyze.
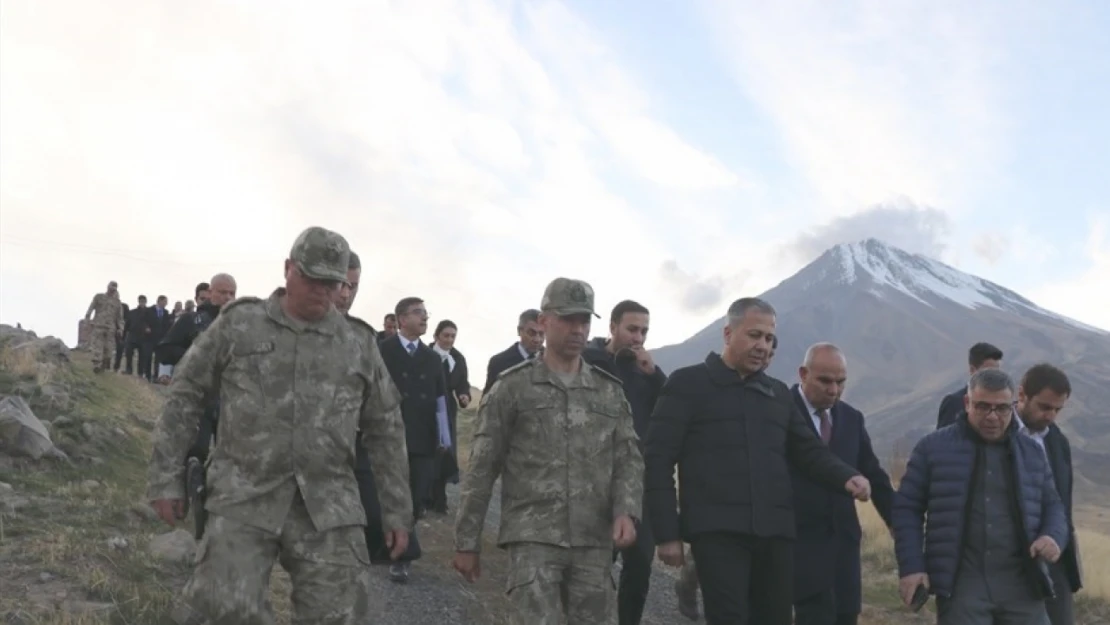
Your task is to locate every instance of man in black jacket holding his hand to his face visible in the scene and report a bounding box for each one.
[582,300,667,625]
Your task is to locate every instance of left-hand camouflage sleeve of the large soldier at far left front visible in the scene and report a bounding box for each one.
[147,316,232,501]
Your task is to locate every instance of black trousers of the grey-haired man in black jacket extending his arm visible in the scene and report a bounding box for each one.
[690,532,794,625]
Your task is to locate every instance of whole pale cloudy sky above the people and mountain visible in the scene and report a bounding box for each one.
[0,0,1110,384]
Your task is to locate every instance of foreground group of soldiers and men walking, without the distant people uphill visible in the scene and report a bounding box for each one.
[123,228,1078,625]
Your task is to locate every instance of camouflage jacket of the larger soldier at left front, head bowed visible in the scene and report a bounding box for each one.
[148,290,412,532]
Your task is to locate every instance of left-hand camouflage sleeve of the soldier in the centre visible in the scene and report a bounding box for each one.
[455,380,516,552]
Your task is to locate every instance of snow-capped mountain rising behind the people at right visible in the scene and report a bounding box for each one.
[654,239,1110,499]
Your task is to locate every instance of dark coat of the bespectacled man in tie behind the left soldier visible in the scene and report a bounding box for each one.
[379,336,454,455]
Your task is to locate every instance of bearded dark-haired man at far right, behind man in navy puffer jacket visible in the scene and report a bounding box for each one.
[1017,364,1083,625]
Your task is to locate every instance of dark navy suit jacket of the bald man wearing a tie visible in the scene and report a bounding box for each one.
[790,384,895,614]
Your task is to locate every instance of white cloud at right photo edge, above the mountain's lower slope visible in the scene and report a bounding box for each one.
[1029,212,1110,331]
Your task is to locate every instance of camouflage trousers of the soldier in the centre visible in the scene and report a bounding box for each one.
[507,543,616,625]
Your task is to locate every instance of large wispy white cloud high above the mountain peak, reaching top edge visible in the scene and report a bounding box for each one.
[704,0,1013,215]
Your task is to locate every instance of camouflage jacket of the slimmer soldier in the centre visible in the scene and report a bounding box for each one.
[455,359,644,552]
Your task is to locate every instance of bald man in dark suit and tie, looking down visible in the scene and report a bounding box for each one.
[790,343,894,625]
